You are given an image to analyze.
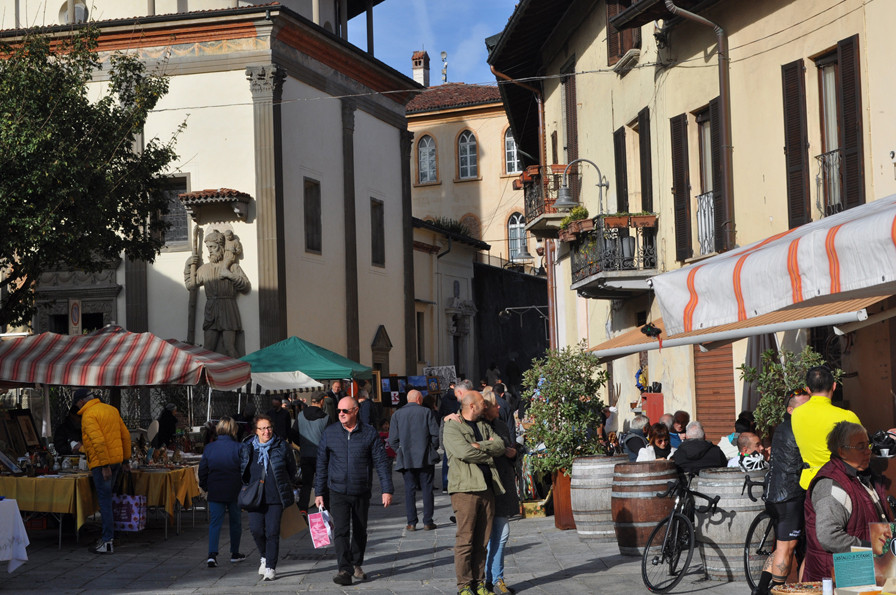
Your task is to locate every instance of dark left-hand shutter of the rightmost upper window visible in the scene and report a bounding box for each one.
[781,60,811,229]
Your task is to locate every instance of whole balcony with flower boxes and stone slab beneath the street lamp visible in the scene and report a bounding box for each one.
[570,215,658,299]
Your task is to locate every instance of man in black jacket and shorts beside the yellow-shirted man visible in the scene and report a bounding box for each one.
[753,390,809,595]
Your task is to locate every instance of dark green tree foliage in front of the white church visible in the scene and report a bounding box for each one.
[0,28,183,324]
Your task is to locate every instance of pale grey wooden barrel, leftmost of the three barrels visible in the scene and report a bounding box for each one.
[570,455,628,541]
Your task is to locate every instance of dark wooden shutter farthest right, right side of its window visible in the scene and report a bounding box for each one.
[837,35,865,209]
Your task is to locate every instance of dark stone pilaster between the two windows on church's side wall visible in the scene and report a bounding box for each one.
[341,98,361,361]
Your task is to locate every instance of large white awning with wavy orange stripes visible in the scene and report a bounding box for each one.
[651,195,896,335]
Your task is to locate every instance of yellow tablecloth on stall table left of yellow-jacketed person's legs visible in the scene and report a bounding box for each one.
[0,473,99,529]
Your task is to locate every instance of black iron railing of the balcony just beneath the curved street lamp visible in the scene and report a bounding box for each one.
[570,218,657,283]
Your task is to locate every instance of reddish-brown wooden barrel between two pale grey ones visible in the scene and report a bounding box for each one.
[611,461,678,556]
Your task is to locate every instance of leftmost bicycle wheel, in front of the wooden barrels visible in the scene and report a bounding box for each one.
[641,512,694,593]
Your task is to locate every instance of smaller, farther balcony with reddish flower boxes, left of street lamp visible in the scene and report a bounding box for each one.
[520,165,581,238]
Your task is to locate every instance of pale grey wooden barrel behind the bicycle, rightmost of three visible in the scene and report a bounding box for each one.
[692,468,766,581]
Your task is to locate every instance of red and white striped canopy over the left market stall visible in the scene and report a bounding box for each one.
[0,327,250,391]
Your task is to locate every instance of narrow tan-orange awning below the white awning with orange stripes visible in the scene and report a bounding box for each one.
[590,296,889,362]
